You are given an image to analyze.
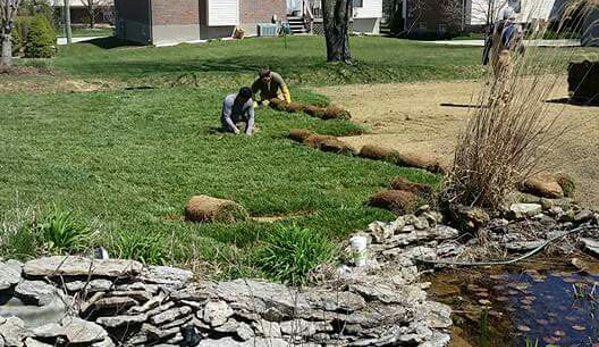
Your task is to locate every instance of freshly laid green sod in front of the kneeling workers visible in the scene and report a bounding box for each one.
[0,87,438,276]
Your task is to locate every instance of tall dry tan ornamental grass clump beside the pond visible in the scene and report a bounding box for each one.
[444,0,598,210]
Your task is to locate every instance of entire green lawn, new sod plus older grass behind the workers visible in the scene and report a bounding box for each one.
[0,37,592,276]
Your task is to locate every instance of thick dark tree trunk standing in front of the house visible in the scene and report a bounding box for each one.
[322,0,352,63]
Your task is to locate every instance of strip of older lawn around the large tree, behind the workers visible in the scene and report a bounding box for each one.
[52,36,482,88]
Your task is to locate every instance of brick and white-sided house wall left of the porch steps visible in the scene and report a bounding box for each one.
[115,0,287,45]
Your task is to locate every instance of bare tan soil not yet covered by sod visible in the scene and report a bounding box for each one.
[318,81,599,207]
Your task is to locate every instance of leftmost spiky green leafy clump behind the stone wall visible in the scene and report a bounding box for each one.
[33,207,90,254]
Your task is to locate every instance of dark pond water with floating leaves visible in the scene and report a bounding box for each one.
[426,262,599,347]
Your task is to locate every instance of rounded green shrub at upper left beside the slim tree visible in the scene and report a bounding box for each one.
[25,16,56,58]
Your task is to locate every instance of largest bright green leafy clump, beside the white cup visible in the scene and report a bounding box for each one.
[256,225,336,284]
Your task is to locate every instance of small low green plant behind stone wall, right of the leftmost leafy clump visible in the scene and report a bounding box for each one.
[110,231,169,264]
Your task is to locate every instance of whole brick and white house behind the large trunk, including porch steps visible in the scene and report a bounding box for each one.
[115,0,383,45]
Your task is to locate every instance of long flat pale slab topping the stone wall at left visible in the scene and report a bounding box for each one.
[23,256,143,278]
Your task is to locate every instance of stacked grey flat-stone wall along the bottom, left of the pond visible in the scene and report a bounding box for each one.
[0,256,452,347]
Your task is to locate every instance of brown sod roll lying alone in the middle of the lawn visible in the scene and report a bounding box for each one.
[185,195,249,224]
